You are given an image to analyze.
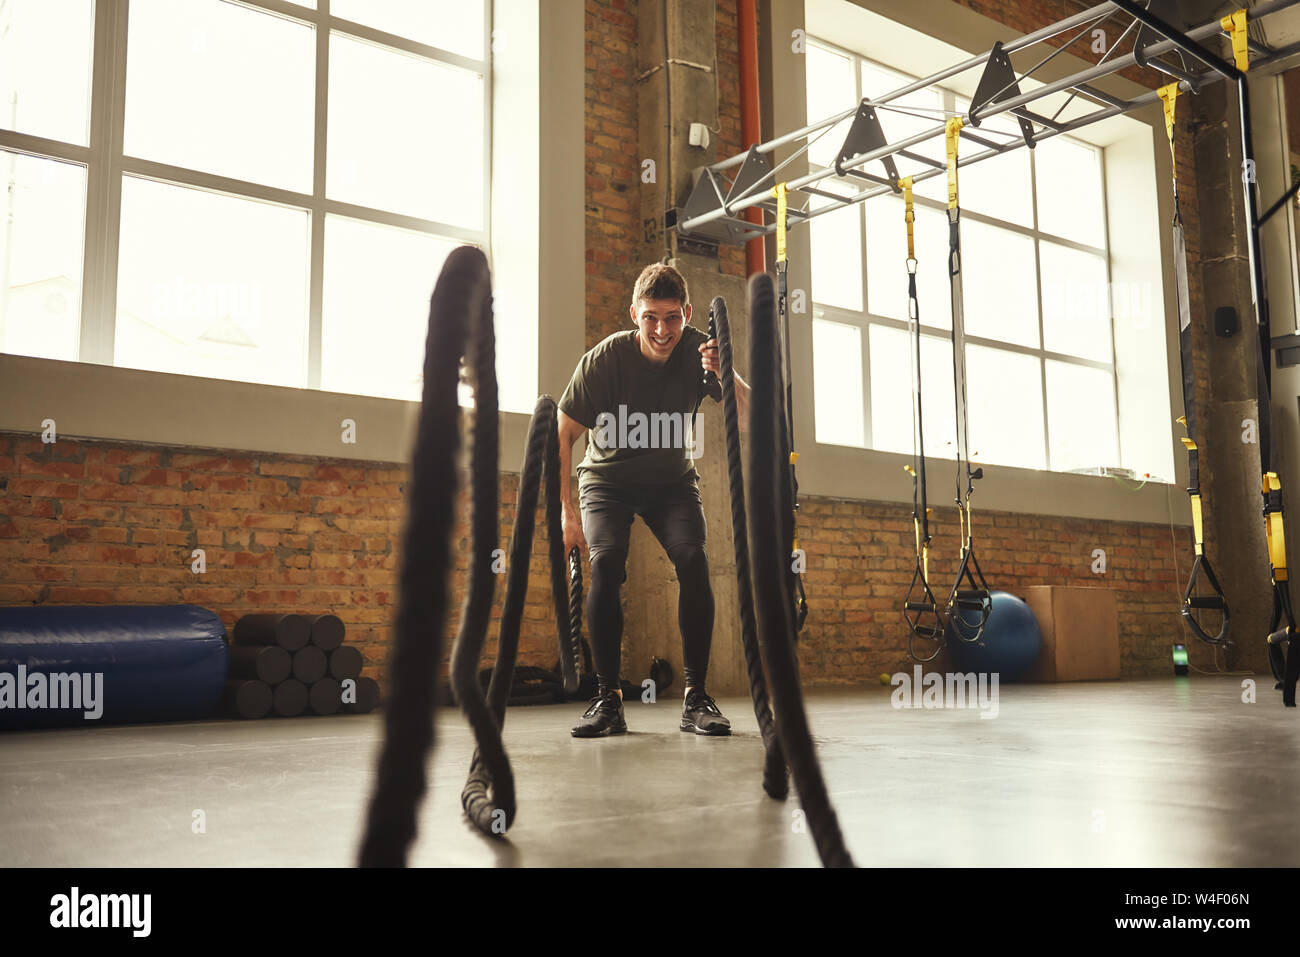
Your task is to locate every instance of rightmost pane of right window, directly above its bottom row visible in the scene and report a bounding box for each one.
[1039,242,1112,363]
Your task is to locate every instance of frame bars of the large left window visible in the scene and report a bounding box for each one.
[0,0,493,390]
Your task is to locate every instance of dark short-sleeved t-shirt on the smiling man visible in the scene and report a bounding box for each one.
[559,325,709,489]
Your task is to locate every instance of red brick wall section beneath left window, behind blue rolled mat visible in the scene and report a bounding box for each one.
[0,434,556,684]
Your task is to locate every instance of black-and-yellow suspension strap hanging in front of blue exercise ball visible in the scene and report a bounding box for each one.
[944,117,993,642]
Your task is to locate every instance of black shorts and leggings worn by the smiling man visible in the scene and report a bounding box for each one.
[579,481,714,688]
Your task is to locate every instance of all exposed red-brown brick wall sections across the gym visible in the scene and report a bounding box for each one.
[0,0,1209,683]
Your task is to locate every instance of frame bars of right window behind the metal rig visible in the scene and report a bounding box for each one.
[807,36,1123,471]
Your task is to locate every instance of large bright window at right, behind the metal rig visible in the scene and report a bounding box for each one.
[807,42,1126,471]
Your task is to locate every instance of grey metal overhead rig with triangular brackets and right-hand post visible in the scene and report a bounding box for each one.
[664,0,1300,707]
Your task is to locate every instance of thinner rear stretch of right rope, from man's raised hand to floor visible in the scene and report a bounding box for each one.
[709,296,790,800]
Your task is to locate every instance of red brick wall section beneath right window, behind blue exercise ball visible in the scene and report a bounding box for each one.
[800,498,1190,683]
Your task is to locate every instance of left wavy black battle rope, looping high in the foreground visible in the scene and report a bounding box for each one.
[360,246,577,867]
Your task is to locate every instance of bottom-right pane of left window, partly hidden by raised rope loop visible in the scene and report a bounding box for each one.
[321,216,459,400]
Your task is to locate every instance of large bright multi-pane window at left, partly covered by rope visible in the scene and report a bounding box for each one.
[0,0,490,399]
